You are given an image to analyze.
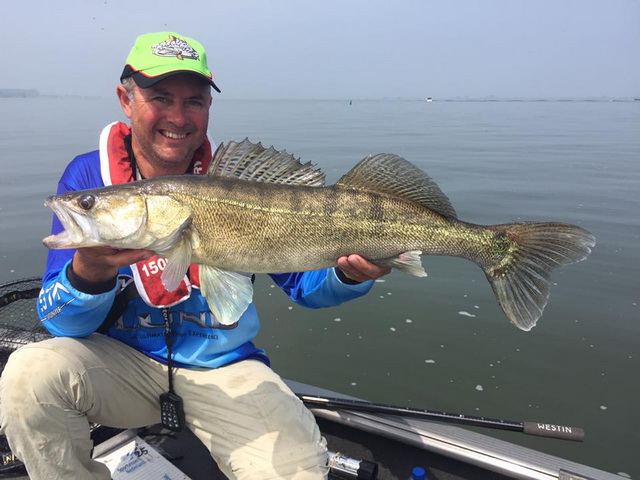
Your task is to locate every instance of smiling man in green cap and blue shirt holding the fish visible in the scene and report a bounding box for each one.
[0,33,388,480]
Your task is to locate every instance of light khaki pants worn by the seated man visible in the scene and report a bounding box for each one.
[0,334,327,480]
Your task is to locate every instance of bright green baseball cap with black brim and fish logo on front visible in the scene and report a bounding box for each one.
[120,32,220,92]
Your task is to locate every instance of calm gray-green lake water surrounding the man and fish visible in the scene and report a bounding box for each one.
[0,97,640,478]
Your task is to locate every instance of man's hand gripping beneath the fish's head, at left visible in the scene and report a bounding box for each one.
[71,247,154,283]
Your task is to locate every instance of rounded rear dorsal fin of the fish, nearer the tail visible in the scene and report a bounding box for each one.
[336,153,457,218]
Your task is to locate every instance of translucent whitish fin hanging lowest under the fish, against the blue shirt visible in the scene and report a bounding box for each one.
[198,265,253,325]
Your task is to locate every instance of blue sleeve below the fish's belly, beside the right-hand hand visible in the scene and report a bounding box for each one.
[271,268,374,308]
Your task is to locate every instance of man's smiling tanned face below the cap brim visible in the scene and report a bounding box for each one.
[118,74,211,177]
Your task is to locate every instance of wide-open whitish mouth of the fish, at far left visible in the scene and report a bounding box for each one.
[42,197,97,249]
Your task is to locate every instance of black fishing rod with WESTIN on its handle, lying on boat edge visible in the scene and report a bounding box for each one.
[297,394,584,442]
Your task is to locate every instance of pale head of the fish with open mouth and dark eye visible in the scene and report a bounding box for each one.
[43,186,148,249]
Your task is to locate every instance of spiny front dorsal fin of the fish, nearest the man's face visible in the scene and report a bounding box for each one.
[207,138,324,187]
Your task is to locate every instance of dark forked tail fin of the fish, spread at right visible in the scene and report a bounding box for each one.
[482,222,596,331]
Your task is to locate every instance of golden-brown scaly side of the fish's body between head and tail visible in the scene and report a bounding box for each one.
[160,177,475,273]
